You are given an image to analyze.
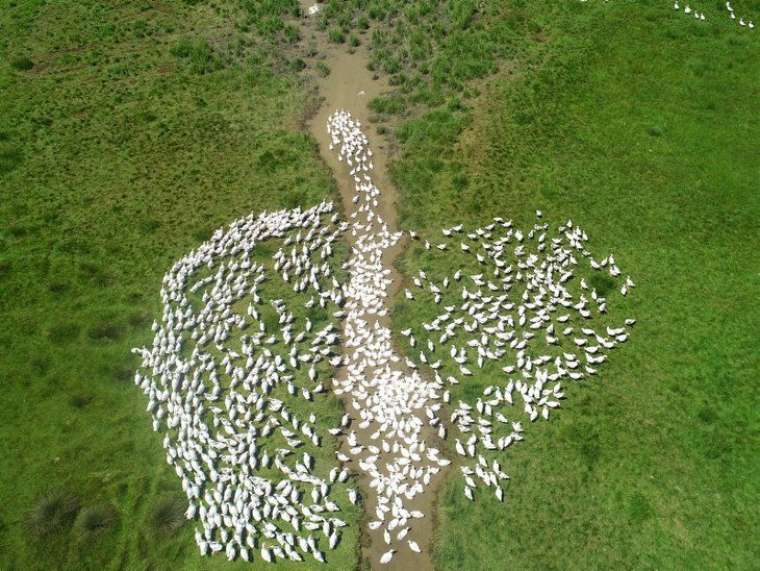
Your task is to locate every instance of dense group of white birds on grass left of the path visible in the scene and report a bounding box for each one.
[135,203,357,561]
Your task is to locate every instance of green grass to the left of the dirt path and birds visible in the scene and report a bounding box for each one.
[0,0,356,570]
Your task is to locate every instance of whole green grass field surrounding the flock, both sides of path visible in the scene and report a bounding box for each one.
[0,0,760,570]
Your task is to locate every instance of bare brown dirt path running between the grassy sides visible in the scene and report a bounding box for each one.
[301,5,443,571]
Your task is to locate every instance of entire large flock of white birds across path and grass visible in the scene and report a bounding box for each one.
[135,111,634,563]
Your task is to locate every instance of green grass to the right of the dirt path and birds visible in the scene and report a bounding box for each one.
[380,1,760,570]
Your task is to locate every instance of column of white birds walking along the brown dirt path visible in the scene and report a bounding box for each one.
[327,111,450,563]
